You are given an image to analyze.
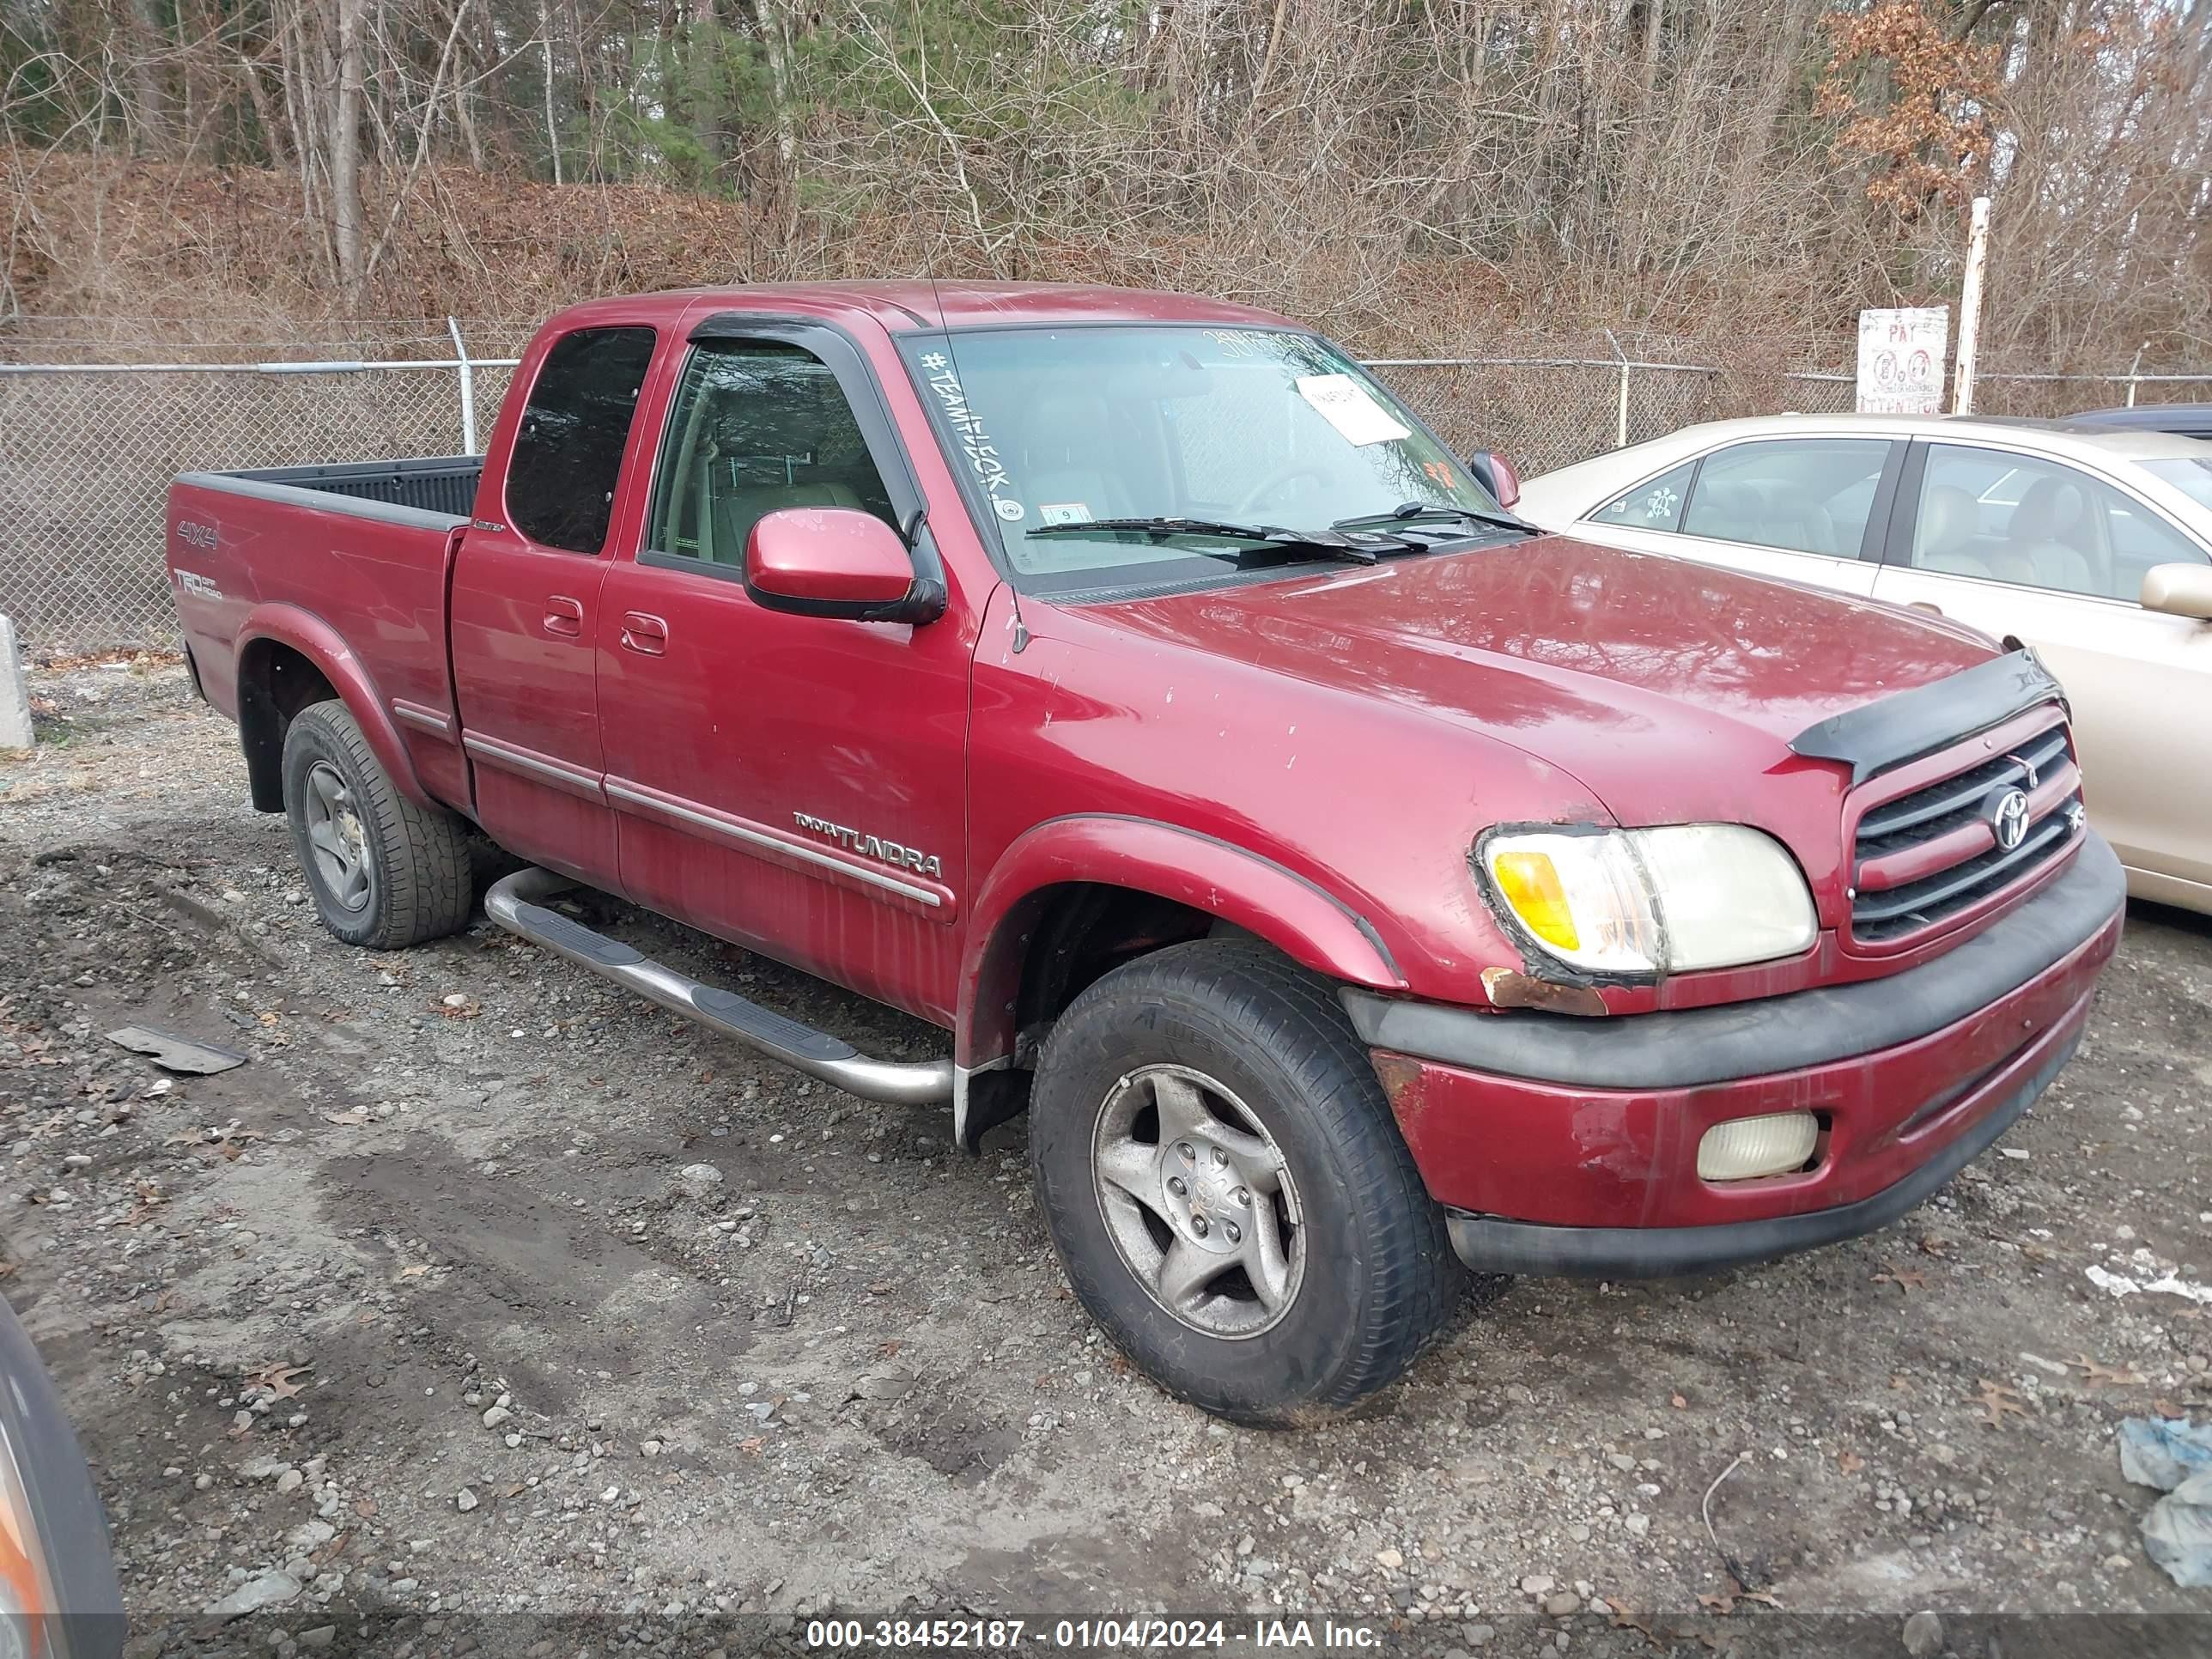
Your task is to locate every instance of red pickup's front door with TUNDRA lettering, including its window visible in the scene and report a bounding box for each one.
[598,316,973,1024]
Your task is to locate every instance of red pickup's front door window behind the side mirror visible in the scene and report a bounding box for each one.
[646,341,898,566]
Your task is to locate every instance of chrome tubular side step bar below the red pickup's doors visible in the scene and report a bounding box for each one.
[484,867,953,1106]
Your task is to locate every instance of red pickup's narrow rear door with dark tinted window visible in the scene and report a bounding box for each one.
[449,325,654,887]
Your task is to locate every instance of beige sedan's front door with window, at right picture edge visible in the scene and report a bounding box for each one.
[1874,441,2212,897]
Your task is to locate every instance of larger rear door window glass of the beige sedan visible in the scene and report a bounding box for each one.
[1681,438,1889,560]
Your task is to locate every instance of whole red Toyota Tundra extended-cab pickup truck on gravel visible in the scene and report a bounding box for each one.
[168,283,2121,1422]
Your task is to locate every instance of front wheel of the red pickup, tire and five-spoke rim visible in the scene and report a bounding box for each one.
[1029,940,1462,1425]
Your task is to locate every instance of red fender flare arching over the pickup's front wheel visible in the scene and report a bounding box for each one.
[953,814,1407,1071]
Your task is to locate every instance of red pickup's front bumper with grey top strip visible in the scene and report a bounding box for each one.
[1343,834,2126,1279]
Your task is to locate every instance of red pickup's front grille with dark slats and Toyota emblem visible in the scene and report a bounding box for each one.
[1851,721,2081,947]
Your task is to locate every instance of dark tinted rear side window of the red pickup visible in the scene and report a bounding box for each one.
[507,327,653,553]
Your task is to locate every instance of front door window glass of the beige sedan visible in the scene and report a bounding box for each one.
[1911,445,2205,602]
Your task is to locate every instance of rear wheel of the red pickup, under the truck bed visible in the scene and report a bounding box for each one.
[283,702,473,951]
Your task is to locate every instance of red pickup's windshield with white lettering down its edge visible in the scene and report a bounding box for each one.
[907,325,1500,588]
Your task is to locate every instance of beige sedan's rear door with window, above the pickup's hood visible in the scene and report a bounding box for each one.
[1589,438,1902,598]
